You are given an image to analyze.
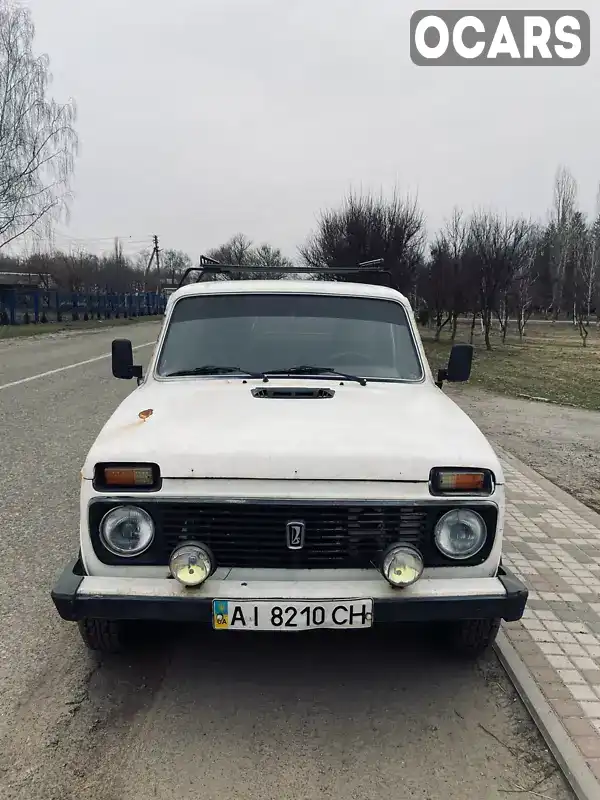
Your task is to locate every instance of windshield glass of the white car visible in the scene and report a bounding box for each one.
[157,292,423,381]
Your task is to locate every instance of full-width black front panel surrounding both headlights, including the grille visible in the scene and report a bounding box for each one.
[89,496,498,569]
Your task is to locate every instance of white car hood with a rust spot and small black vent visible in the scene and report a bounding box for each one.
[83,378,503,483]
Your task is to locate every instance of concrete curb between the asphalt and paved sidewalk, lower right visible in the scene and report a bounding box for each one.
[494,630,600,800]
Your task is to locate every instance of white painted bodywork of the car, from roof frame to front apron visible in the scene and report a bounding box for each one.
[80,280,505,598]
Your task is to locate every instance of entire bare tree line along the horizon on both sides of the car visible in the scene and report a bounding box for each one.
[0,168,600,349]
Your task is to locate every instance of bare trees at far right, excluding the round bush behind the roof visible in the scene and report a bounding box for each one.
[416,168,600,349]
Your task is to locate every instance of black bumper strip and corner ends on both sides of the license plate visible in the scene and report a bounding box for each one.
[51,559,529,627]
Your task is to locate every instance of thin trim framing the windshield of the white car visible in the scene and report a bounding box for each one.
[147,290,428,385]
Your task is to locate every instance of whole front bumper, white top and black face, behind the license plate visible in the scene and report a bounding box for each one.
[51,559,528,626]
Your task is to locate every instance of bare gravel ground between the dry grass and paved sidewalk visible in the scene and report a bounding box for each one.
[445,386,600,512]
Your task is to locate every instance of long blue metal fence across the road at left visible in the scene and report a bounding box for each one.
[0,287,167,325]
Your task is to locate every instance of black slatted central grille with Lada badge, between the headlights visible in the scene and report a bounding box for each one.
[161,503,427,569]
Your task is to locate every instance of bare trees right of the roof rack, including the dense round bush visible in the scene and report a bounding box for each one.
[300,167,600,349]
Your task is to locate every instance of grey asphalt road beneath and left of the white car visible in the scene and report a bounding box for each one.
[0,323,572,800]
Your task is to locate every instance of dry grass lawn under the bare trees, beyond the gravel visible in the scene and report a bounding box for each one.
[421,322,600,411]
